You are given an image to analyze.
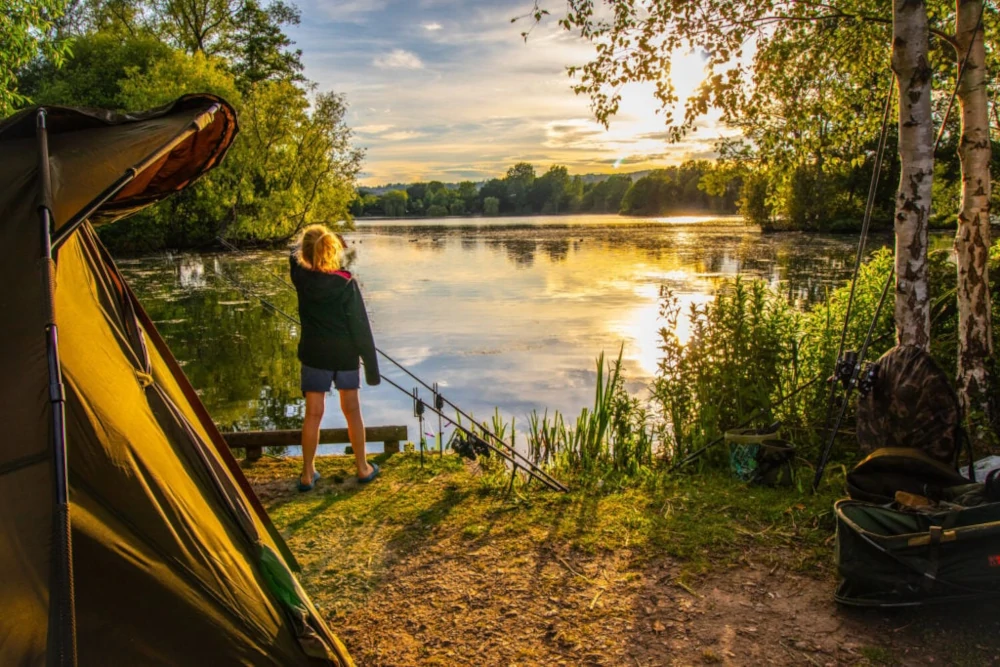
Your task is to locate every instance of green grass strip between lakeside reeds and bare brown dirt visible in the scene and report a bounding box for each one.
[246,454,841,612]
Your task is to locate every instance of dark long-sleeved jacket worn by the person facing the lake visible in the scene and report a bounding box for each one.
[289,253,381,386]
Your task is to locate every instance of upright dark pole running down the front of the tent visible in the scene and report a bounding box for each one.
[36,109,76,667]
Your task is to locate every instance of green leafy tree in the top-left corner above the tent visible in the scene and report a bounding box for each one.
[0,0,69,117]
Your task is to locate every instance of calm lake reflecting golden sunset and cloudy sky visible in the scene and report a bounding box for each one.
[119,215,891,453]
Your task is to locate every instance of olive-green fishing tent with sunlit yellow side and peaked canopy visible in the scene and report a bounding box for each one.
[0,95,353,666]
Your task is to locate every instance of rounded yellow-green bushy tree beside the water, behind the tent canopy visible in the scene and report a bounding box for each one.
[99,51,360,250]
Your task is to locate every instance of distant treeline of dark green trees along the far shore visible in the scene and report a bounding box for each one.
[351,160,740,218]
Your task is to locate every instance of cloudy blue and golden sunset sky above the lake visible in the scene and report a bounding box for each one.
[289,0,732,185]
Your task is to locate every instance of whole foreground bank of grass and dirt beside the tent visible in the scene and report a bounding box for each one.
[246,455,1000,665]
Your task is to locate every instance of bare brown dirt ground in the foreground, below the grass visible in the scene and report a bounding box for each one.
[244,456,1000,667]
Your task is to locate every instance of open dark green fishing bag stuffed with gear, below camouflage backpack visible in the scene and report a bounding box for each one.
[834,449,1000,607]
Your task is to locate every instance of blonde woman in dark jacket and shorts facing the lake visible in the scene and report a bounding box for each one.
[289,225,381,491]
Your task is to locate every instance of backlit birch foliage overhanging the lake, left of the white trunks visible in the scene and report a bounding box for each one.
[535,0,1000,230]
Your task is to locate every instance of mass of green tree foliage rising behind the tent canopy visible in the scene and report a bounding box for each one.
[13,0,362,251]
